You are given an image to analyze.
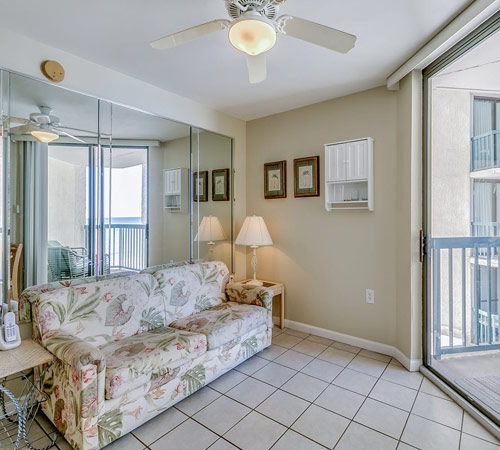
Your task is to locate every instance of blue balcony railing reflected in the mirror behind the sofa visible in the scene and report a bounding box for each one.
[85,224,147,271]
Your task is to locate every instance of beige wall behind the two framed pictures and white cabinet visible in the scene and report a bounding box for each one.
[247,75,421,358]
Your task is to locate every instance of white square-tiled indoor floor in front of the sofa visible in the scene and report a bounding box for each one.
[21,328,500,450]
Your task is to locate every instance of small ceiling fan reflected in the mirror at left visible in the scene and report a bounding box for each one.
[10,106,85,144]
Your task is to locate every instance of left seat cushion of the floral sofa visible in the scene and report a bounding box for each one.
[99,327,207,400]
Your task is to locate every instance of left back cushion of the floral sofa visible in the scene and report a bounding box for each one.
[34,274,166,345]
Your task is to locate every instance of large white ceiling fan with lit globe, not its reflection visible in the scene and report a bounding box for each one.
[151,0,356,84]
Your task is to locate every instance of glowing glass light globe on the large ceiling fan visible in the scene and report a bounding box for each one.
[229,18,276,56]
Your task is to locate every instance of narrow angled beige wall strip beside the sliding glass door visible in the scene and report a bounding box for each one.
[394,71,423,360]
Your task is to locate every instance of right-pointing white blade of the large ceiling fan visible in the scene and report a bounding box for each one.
[278,16,356,53]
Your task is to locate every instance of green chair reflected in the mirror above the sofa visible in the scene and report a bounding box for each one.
[47,241,89,281]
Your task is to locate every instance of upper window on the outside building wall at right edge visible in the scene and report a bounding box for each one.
[472,97,500,171]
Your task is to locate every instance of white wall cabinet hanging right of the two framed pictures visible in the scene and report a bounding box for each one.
[325,138,374,211]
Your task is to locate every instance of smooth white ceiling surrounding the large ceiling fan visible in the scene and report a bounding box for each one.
[0,0,471,120]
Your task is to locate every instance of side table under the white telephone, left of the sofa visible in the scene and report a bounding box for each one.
[0,340,57,450]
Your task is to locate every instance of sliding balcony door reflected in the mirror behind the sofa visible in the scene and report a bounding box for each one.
[47,145,148,281]
